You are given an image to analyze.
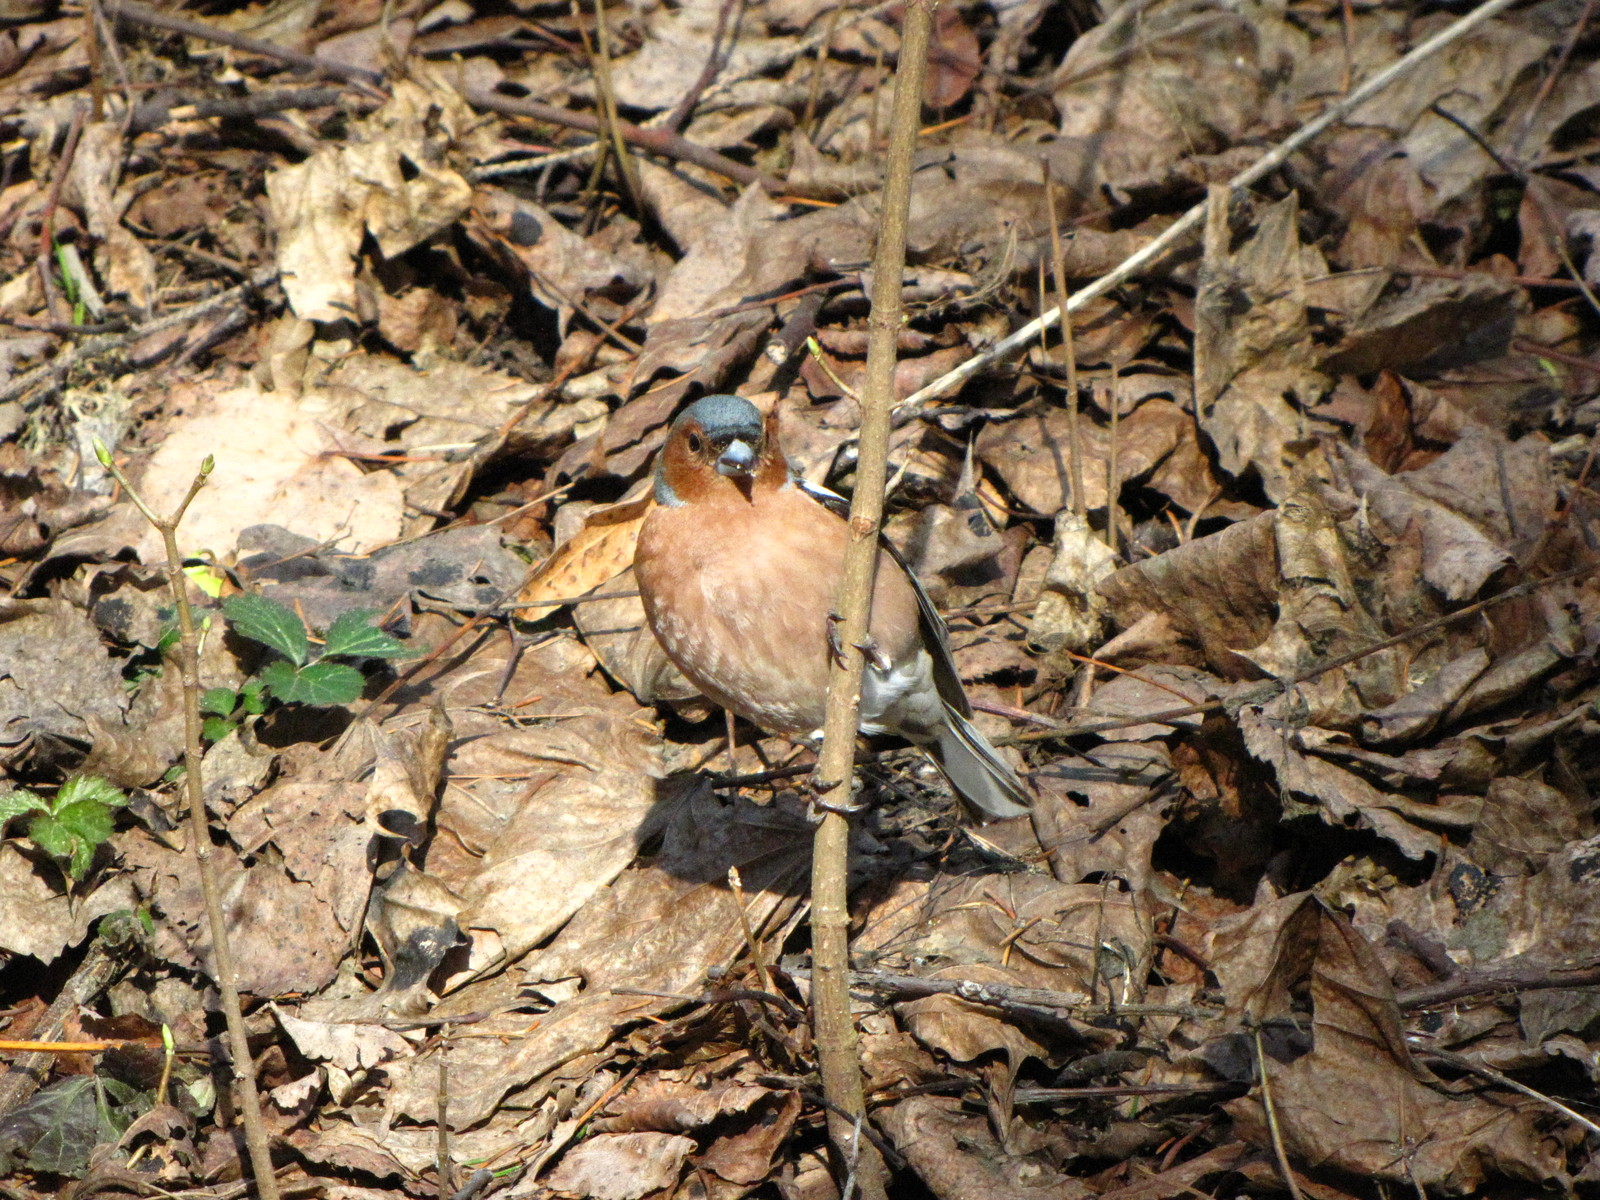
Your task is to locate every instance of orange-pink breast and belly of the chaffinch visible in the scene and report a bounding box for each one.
[634,486,920,734]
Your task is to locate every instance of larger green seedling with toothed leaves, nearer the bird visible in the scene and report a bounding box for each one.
[200,594,411,741]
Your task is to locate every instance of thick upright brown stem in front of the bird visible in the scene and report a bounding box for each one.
[811,0,933,1200]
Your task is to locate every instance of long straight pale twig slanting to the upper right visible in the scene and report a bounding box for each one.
[894,0,1517,426]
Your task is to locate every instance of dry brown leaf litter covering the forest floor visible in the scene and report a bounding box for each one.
[0,0,1600,1200]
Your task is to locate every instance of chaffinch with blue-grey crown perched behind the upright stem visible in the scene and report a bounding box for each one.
[634,395,1030,818]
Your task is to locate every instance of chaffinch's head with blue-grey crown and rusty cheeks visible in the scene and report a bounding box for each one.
[656,395,789,507]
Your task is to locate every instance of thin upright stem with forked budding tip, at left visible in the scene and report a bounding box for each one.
[94,445,278,1200]
